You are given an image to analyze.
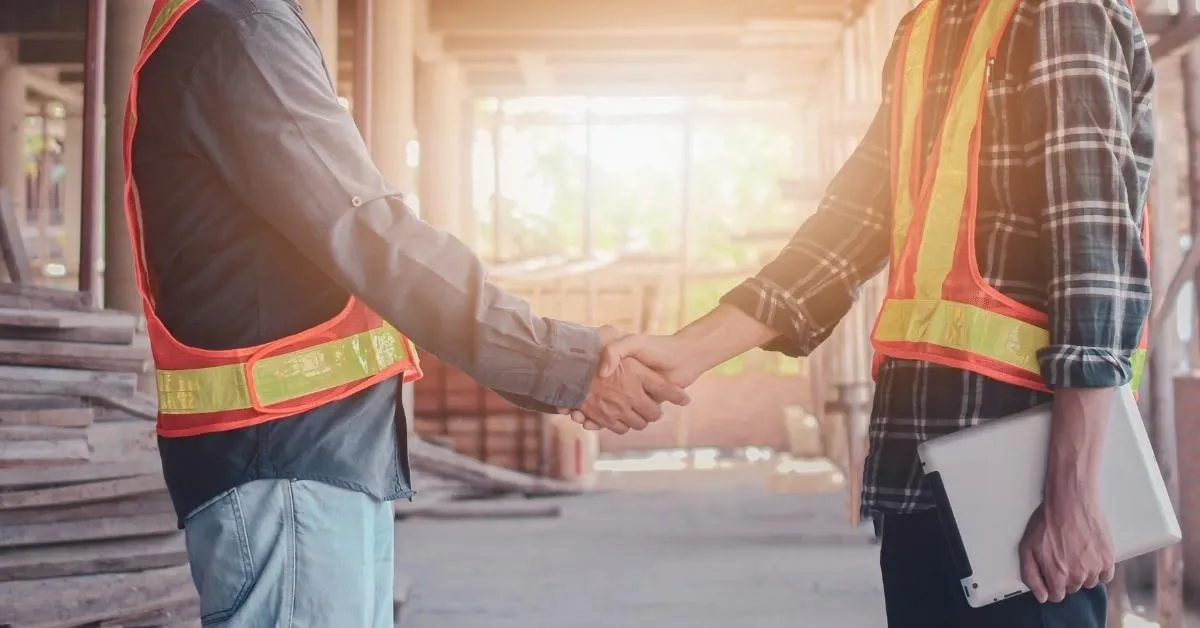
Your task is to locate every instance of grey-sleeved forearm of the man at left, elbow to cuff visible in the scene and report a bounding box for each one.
[328,198,600,408]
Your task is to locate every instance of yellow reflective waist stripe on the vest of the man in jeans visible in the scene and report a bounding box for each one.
[157,323,415,414]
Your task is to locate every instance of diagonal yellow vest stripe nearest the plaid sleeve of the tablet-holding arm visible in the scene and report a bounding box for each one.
[913,0,1016,299]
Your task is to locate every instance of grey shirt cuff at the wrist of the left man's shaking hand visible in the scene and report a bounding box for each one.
[529,319,602,409]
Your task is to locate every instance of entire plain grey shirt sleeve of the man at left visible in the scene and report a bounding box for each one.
[184,12,600,408]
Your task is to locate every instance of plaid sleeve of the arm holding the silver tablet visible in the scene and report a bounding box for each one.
[1025,0,1154,388]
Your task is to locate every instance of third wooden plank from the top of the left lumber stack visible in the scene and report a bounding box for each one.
[0,339,150,373]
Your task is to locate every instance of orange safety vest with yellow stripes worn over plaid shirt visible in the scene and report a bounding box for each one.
[871,0,1150,391]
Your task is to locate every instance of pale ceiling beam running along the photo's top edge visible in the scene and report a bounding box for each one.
[430,0,848,32]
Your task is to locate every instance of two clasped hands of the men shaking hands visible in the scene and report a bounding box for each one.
[562,327,703,433]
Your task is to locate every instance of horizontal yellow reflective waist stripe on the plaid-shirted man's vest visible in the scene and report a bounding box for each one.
[875,299,1050,373]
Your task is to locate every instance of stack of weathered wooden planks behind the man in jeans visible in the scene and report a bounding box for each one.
[0,283,198,628]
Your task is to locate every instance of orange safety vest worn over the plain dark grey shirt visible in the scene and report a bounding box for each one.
[125,0,421,437]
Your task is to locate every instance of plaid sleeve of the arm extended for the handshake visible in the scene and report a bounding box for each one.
[721,31,894,357]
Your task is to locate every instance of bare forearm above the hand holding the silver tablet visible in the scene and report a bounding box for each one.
[1045,388,1116,509]
